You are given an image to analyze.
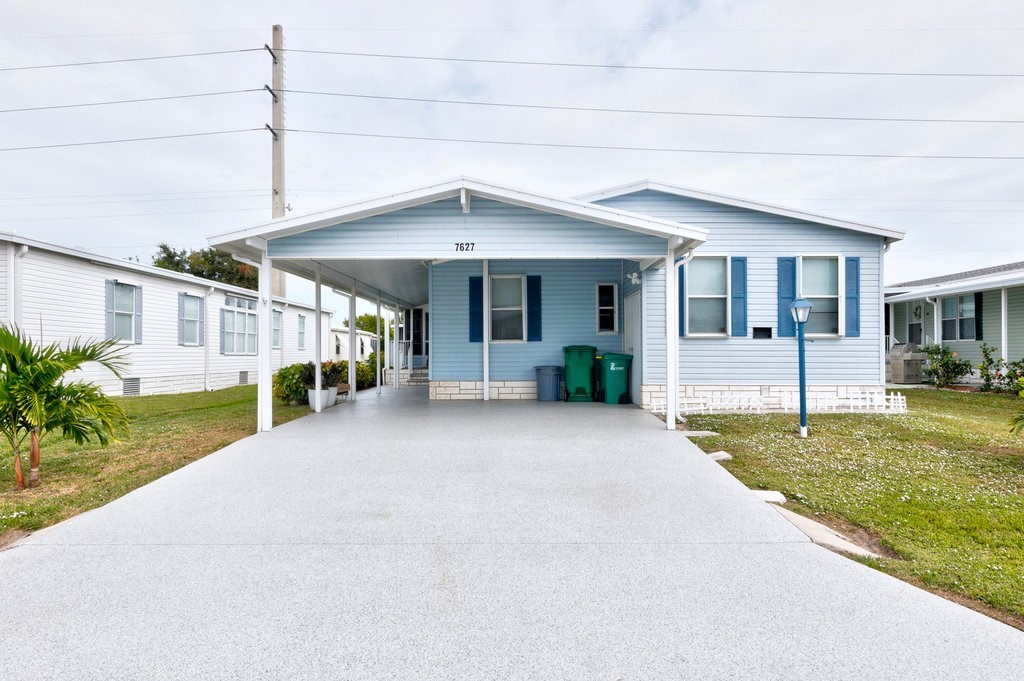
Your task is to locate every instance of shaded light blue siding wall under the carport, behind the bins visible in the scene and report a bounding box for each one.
[430,258,629,381]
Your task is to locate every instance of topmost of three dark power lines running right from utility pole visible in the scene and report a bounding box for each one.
[284,48,1024,78]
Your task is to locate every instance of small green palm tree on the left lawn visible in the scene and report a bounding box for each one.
[0,325,128,490]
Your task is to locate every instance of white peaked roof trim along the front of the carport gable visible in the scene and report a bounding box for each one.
[208,177,709,246]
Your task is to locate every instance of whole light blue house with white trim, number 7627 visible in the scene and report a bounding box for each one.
[210,178,903,429]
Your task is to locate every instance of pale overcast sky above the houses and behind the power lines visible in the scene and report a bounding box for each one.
[0,0,1024,309]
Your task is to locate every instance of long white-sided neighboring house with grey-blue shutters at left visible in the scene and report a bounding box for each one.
[0,232,333,394]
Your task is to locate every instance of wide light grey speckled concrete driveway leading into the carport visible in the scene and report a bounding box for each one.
[0,389,1024,680]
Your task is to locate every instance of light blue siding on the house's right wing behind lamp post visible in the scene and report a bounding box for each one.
[600,190,884,385]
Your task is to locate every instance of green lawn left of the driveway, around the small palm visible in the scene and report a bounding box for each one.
[0,386,309,546]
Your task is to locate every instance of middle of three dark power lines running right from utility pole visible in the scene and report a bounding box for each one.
[284,90,1024,123]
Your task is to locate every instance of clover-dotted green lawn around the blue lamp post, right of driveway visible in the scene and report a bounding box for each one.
[687,390,1024,628]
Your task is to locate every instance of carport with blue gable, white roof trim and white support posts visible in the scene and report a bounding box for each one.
[209,178,708,431]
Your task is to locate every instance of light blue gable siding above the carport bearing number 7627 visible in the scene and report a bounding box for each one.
[269,198,666,258]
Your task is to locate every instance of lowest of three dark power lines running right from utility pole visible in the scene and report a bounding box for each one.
[284,128,1024,161]
